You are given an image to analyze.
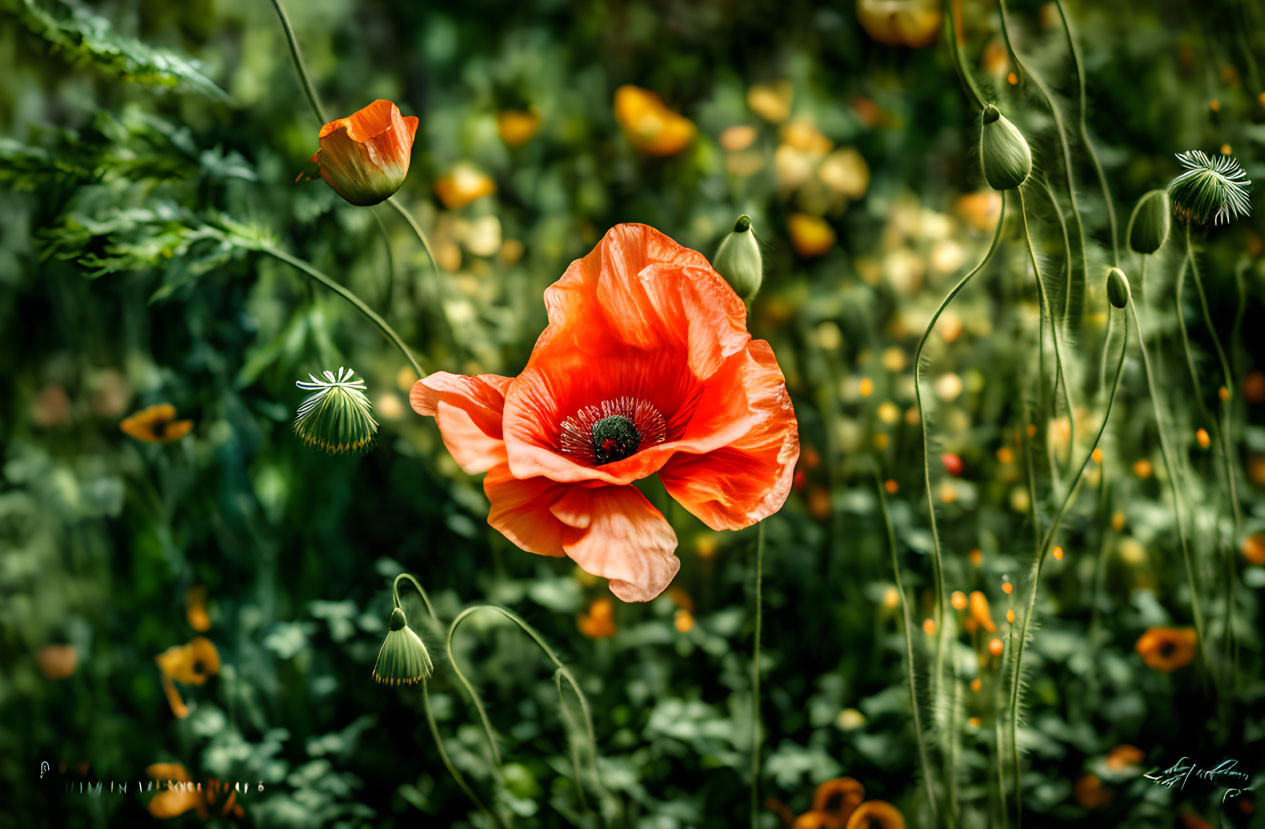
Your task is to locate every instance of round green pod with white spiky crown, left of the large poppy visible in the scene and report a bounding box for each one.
[295,368,378,454]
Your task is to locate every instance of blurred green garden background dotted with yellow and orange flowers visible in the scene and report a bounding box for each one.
[7,0,1265,828]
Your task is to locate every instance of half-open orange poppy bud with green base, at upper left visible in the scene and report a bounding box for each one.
[311,100,417,206]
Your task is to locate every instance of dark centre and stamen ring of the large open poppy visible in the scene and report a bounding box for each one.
[558,397,668,466]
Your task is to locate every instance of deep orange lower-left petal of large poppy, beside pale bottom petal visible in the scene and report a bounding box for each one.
[483,463,574,556]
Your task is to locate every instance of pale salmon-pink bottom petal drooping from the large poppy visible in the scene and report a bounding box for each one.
[549,486,681,601]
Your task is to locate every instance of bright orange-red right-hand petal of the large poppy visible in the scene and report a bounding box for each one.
[659,340,799,529]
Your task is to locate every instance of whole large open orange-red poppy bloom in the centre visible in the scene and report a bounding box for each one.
[410,224,799,601]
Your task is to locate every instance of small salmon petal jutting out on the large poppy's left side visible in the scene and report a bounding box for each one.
[409,371,510,475]
